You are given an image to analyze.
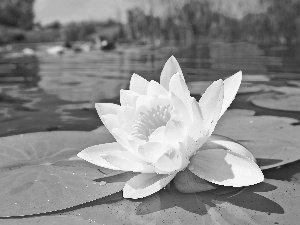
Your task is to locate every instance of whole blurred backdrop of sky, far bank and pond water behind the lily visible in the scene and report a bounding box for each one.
[0,0,300,136]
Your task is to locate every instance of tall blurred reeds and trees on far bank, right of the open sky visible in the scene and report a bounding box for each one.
[127,0,300,44]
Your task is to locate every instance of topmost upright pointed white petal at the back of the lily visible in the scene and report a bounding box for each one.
[160,56,182,90]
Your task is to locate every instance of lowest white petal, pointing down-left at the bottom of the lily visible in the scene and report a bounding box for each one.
[123,173,176,199]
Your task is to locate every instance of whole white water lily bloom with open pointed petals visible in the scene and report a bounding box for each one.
[78,56,264,199]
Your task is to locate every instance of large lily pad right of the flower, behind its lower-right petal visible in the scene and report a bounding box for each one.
[214,109,300,169]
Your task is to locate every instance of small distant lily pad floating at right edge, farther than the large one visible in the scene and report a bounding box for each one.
[249,92,300,112]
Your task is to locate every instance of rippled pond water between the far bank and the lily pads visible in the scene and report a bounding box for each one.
[0,42,300,136]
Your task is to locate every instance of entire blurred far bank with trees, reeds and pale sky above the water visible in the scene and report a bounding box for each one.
[0,0,300,45]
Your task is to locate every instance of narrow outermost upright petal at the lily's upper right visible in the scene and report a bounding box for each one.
[220,71,242,117]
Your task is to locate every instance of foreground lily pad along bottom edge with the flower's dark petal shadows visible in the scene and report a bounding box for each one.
[60,179,300,225]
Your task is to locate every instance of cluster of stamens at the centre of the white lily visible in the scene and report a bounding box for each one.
[131,105,171,141]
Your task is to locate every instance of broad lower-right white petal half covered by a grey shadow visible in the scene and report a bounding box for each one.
[188,149,264,187]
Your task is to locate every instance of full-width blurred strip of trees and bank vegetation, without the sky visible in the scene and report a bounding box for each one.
[0,0,300,44]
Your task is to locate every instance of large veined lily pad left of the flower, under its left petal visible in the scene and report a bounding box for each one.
[0,131,129,217]
